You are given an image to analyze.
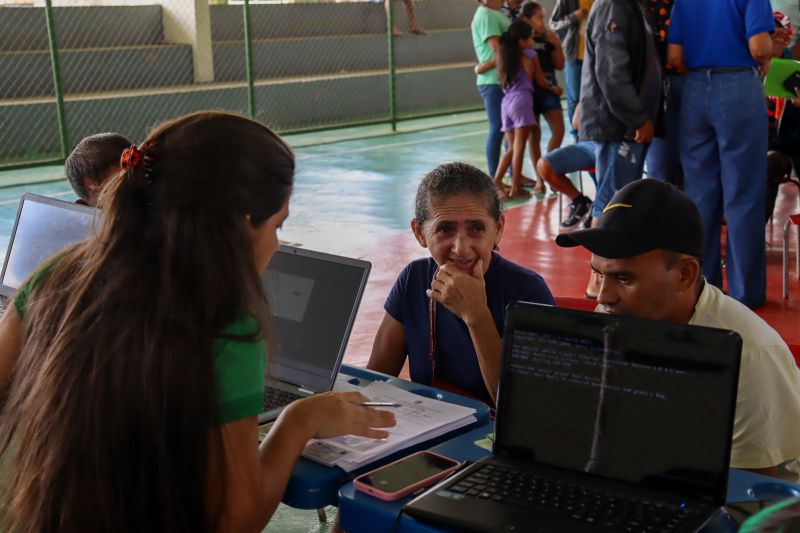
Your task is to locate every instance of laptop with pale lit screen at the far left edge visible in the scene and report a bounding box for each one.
[0,192,95,309]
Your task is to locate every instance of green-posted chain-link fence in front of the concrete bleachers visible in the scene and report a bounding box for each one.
[0,0,482,168]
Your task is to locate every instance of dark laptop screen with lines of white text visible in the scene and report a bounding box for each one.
[496,304,741,501]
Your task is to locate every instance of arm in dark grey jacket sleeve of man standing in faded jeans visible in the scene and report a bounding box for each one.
[591,3,649,135]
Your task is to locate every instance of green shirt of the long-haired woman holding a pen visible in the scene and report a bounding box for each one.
[14,263,266,425]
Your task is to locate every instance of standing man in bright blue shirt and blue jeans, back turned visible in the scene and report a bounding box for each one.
[668,0,775,307]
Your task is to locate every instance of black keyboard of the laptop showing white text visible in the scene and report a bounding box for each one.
[447,465,696,532]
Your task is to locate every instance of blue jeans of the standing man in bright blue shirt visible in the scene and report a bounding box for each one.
[680,70,767,307]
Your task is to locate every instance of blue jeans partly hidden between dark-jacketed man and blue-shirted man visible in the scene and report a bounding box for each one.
[647,74,686,189]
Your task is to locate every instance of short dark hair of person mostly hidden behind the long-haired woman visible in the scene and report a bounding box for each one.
[64,133,133,201]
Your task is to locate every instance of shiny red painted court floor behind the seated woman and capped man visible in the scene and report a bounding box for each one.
[345,185,800,366]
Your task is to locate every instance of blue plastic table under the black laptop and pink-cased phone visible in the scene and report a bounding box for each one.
[338,424,800,533]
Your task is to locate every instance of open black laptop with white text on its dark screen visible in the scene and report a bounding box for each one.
[405,302,741,532]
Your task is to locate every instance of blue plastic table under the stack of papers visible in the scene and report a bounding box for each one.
[282,365,489,509]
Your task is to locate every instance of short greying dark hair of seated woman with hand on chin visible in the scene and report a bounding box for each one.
[414,162,503,222]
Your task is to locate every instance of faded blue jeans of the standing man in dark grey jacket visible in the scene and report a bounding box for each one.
[592,141,648,217]
